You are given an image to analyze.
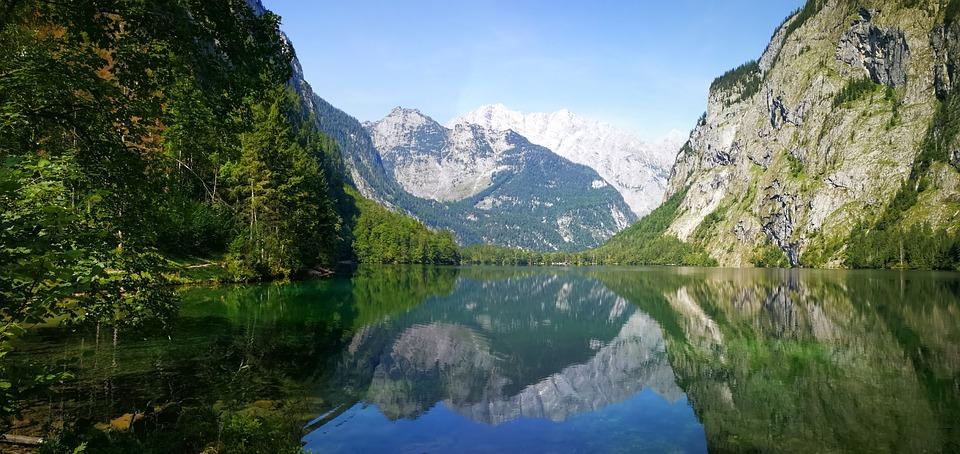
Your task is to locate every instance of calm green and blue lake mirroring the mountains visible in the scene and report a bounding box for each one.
[15,267,960,454]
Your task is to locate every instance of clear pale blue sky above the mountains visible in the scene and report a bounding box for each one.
[264,0,803,138]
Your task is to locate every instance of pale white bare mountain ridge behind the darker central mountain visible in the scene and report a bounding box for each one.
[449,104,685,216]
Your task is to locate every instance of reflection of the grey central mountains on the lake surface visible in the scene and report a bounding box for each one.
[341,274,683,425]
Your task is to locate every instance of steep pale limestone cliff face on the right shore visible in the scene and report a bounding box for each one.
[667,0,960,266]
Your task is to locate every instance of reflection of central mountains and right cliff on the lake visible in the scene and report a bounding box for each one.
[307,268,960,452]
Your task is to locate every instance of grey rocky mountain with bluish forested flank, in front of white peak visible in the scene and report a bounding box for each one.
[348,108,636,251]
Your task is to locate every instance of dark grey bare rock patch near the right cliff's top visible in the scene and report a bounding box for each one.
[837,9,910,87]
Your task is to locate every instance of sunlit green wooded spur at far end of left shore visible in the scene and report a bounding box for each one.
[349,190,460,265]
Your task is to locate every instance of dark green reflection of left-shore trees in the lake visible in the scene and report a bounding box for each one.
[28,278,364,454]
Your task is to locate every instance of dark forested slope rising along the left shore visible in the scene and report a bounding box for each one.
[0,0,455,432]
